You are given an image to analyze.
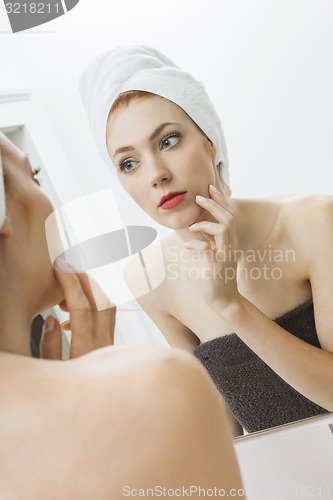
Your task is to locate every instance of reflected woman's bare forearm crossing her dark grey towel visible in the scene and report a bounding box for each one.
[215,297,333,411]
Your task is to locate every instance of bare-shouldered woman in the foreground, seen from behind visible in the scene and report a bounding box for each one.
[0,133,244,500]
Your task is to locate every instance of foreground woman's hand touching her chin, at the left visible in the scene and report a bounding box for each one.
[40,271,116,359]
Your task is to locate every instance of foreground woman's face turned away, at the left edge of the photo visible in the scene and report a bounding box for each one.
[0,135,62,312]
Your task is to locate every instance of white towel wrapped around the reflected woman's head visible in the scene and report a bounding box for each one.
[79,45,229,191]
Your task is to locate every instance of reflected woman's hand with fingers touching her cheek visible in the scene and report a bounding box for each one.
[185,186,241,313]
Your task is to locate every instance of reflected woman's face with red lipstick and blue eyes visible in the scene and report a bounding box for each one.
[106,96,217,229]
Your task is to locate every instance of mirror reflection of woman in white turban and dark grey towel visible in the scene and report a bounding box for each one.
[80,46,333,438]
